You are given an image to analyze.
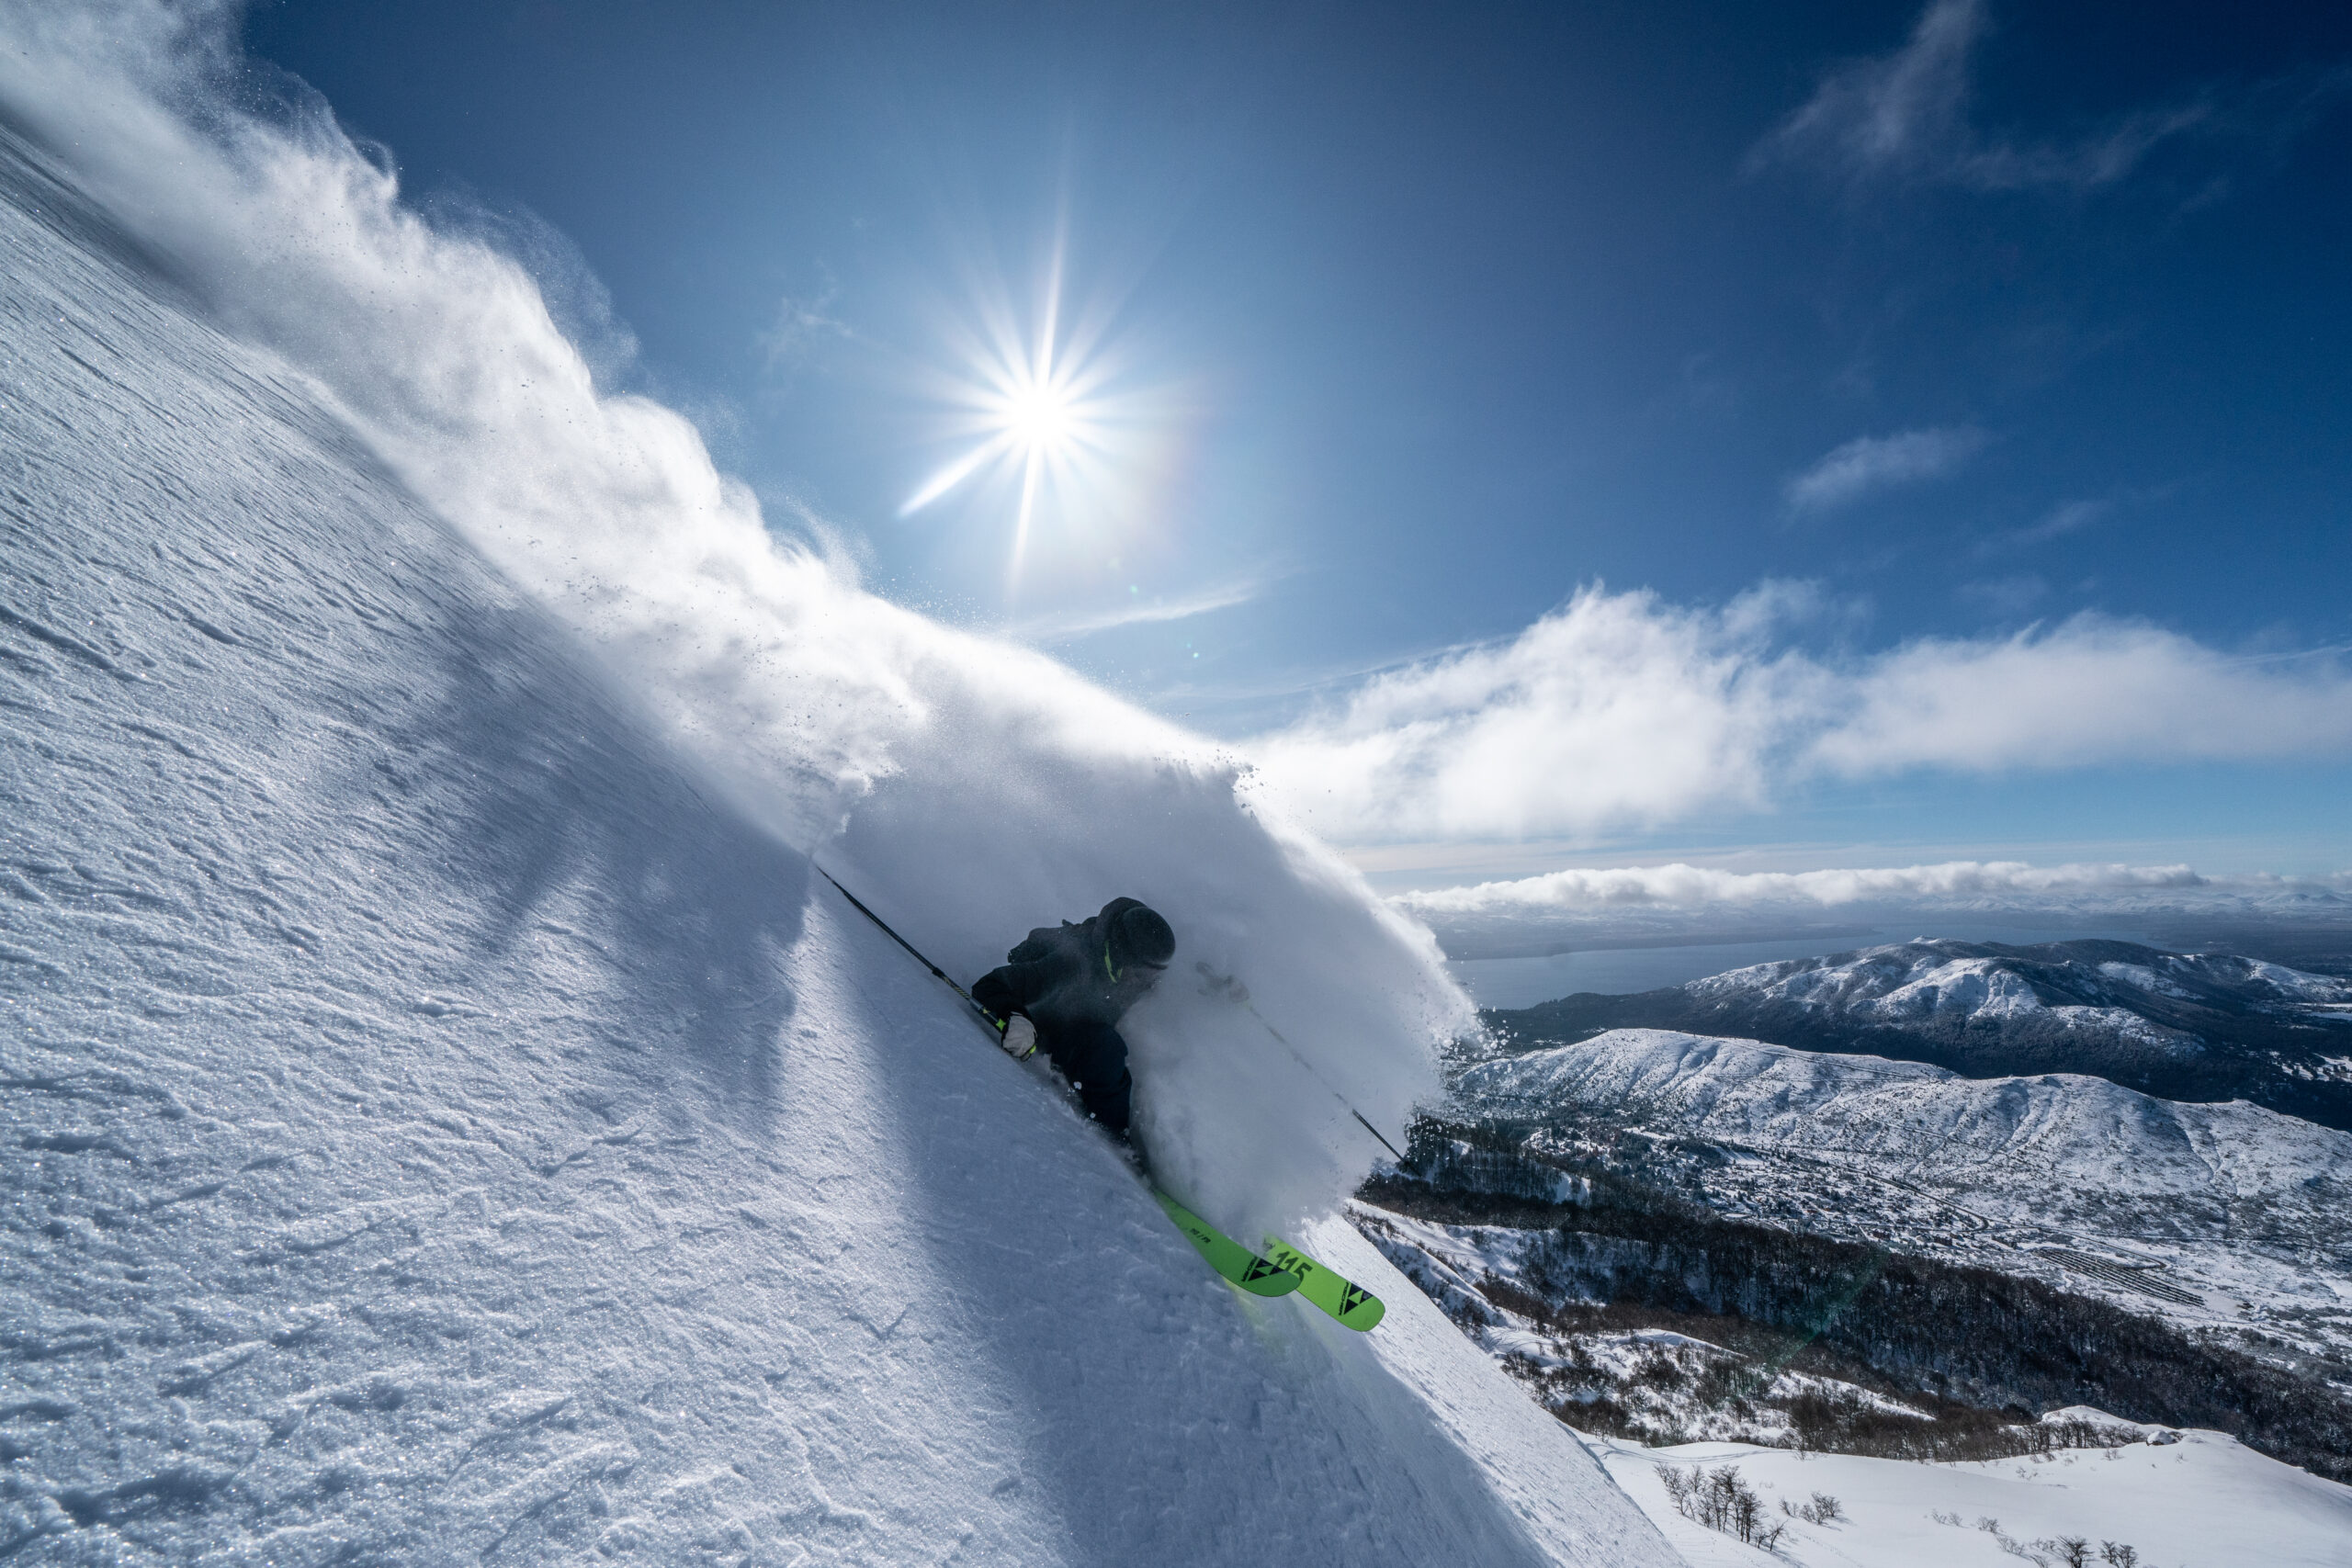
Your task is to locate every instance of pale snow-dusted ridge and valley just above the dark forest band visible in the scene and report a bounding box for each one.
[1458,1030,2352,1349]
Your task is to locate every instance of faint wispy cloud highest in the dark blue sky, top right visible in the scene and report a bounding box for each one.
[1750,0,2218,190]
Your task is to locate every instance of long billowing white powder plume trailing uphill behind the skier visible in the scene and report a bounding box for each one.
[0,3,1467,1227]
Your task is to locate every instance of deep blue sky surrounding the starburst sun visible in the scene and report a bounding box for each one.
[233,0,2352,877]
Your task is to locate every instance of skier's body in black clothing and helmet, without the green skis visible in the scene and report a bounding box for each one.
[971,898,1176,1143]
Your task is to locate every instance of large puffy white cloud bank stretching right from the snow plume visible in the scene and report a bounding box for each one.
[1249,585,2352,844]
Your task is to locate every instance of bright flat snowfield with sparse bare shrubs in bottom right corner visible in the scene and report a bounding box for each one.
[1588,1408,2352,1568]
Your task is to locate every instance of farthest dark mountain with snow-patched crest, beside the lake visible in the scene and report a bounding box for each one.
[1488,941,2352,1128]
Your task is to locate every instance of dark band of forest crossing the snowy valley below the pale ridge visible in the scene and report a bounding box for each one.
[1362,1119,2352,1483]
